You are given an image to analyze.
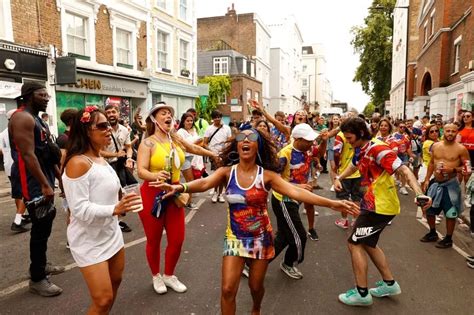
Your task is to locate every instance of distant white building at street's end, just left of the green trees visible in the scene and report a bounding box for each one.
[301,44,333,110]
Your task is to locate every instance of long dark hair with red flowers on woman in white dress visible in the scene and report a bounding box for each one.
[64,106,107,168]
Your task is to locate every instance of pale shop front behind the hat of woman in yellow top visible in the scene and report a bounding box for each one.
[150,78,199,119]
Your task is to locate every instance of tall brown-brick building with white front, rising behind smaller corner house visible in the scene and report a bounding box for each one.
[197,5,271,106]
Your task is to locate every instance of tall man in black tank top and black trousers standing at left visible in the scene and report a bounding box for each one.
[8,82,64,296]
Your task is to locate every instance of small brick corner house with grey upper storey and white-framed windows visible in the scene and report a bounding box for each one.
[197,50,263,123]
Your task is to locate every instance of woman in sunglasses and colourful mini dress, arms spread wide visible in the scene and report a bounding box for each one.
[156,128,358,314]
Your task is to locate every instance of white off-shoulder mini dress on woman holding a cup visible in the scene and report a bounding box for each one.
[62,159,124,267]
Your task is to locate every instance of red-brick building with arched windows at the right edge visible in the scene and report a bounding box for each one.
[407,0,474,118]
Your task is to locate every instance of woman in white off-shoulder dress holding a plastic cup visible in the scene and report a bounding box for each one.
[62,106,141,314]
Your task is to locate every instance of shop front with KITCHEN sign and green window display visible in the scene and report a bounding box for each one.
[56,70,148,133]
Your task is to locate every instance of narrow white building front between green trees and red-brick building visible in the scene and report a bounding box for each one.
[385,0,408,118]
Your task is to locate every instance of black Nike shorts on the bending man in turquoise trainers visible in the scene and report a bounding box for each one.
[348,211,395,248]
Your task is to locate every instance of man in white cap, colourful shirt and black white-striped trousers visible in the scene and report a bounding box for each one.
[272,123,318,280]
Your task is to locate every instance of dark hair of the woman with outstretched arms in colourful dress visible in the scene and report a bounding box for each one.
[220,128,281,173]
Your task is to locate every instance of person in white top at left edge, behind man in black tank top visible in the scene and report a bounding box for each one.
[0,109,31,233]
